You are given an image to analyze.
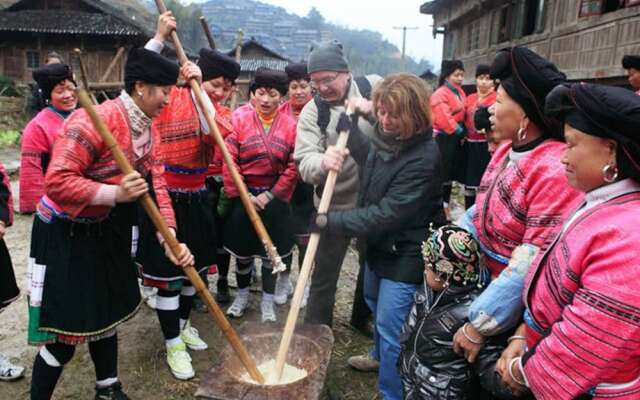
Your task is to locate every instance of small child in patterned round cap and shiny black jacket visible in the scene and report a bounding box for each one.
[398,225,515,400]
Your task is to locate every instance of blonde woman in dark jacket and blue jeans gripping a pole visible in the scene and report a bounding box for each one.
[312,74,444,400]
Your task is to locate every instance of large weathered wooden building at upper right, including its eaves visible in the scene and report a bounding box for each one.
[420,0,640,85]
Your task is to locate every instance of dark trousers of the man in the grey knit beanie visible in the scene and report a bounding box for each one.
[305,234,350,326]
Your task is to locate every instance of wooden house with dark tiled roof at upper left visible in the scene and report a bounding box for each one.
[0,0,155,84]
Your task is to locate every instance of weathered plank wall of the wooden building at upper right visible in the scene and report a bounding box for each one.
[435,0,640,84]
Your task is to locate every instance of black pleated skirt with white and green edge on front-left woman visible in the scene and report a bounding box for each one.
[29,203,141,344]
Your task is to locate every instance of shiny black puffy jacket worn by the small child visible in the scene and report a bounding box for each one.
[398,285,516,400]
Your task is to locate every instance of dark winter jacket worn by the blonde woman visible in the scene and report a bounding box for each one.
[328,122,444,283]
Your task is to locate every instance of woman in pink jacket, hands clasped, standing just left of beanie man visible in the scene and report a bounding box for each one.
[223,68,298,322]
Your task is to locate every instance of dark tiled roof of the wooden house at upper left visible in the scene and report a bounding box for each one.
[0,10,144,36]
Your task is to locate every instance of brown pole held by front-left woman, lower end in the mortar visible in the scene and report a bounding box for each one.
[78,90,264,384]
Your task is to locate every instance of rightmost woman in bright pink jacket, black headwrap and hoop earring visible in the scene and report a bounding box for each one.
[503,83,640,400]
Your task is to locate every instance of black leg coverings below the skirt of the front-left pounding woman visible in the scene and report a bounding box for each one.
[31,335,118,400]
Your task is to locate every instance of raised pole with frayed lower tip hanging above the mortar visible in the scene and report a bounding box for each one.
[155,0,286,274]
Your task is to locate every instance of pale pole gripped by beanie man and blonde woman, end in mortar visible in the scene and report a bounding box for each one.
[275,109,352,382]
